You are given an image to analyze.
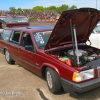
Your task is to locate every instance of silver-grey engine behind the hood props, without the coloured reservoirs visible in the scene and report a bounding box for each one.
[67,49,97,67]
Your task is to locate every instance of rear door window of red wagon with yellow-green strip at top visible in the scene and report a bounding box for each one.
[10,31,21,44]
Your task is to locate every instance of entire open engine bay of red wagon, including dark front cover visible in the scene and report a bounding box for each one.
[48,46,100,70]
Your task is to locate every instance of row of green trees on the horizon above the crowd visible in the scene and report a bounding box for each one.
[9,4,77,14]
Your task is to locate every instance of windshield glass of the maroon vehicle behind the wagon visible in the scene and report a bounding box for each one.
[3,17,28,23]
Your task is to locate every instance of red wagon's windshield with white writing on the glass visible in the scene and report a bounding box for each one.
[33,31,52,49]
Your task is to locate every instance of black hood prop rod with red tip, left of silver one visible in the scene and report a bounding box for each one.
[69,16,77,68]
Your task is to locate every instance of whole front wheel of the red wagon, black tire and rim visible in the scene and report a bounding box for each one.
[46,67,62,94]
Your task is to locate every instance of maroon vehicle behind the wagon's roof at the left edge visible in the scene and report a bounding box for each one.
[0,16,29,33]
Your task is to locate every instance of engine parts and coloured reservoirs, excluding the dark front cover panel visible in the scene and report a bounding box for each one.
[54,48,100,67]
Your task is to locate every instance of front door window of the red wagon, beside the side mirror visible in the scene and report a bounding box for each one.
[21,32,33,47]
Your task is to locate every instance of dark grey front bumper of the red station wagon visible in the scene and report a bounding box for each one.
[61,78,100,93]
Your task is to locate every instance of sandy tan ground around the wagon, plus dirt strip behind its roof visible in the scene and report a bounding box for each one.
[0,22,100,100]
